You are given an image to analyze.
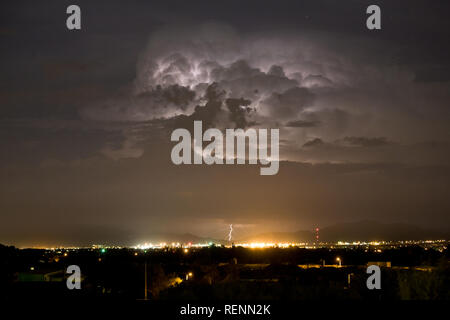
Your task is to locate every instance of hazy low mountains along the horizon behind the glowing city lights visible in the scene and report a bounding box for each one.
[4,220,450,248]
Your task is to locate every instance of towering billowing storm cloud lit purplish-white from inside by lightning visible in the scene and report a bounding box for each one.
[80,24,450,165]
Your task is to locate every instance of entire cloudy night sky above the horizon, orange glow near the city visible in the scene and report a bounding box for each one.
[0,0,450,246]
